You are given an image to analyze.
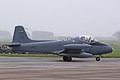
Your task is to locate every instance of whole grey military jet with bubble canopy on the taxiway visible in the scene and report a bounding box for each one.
[9,26,112,61]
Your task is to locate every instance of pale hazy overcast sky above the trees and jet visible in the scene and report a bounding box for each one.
[0,0,120,36]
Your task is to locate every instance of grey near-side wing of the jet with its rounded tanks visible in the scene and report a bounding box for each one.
[57,44,93,58]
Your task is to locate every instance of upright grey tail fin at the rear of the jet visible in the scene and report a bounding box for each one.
[12,26,31,43]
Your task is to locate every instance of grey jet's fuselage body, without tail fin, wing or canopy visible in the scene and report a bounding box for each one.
[13,39,112,55]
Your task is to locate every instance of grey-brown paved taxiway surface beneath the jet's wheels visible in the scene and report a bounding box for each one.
[0,57,120,80]
